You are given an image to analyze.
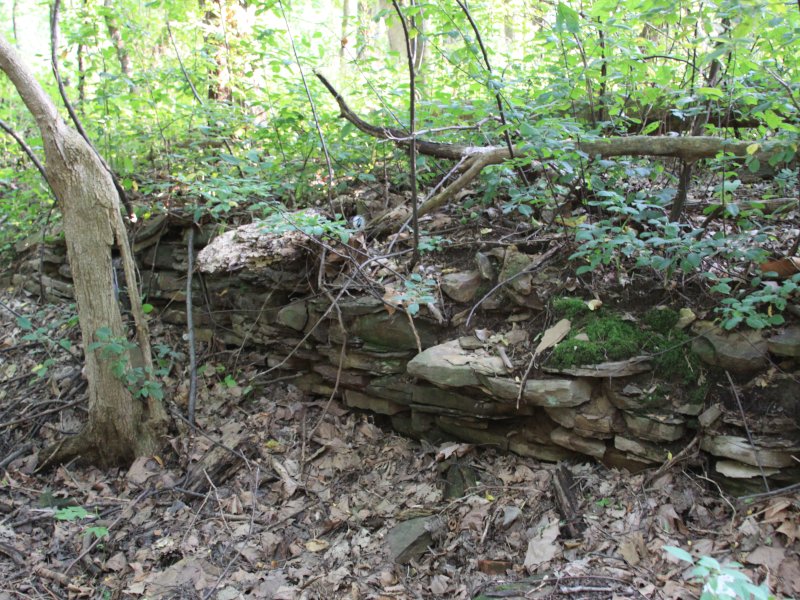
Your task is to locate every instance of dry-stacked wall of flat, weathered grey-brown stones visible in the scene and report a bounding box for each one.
[14,217,800,489]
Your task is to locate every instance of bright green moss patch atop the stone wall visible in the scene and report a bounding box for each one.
[547,298,698,382]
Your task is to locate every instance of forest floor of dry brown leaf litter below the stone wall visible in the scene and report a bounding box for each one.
[0,176,800,600]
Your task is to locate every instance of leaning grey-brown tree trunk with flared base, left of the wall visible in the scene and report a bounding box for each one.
[0,38,167,466]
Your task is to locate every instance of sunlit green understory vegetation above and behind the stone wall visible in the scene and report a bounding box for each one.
[0,0,800,338]
